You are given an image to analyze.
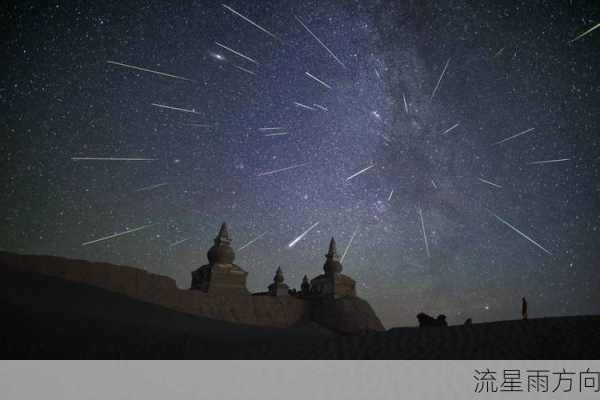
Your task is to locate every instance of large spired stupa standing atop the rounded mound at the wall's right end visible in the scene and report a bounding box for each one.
[310,238,356,298]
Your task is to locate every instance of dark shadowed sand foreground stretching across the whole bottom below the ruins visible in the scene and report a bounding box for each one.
[0,271,600,359]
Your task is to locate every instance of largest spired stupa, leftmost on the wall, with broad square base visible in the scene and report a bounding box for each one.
[191,222,248,294]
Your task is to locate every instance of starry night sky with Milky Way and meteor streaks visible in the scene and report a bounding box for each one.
[0,0,600,327]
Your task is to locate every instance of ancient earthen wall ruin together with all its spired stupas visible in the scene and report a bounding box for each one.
[0,223,384,334]
